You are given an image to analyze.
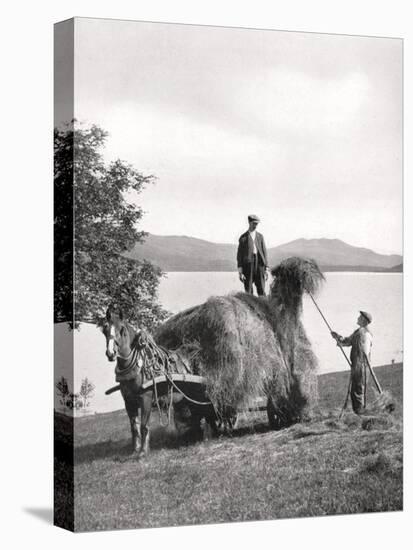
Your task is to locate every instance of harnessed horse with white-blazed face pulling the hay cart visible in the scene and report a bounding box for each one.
[102,306,218,458]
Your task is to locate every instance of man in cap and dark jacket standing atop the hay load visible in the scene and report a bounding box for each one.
[237,214,268,296]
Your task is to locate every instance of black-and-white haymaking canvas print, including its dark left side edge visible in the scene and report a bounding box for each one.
[54,18,403,531]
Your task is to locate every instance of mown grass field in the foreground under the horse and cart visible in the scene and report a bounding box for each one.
[56,364,403,531]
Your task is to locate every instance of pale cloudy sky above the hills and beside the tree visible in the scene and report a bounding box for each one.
[75,19,402,253]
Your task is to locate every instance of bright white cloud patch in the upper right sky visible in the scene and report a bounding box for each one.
[237,69,369,138]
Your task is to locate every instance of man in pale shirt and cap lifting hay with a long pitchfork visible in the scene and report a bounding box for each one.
[331,311,373,414]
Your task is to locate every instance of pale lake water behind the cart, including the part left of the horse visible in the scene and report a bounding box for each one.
[55,272,403,412]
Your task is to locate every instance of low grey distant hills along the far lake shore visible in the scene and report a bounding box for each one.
[128,234,403,272]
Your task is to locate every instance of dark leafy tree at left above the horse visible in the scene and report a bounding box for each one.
[54,121,167,330]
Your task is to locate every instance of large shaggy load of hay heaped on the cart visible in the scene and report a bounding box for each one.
[155,258,323,424]
